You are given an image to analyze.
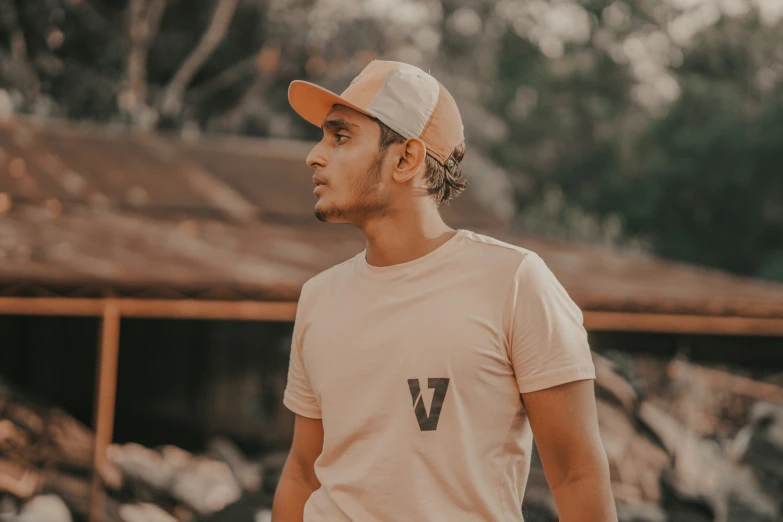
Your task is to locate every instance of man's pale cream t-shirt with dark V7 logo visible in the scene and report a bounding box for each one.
[283,230,595,522]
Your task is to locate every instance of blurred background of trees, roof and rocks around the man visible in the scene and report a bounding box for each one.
[0,0,783,522]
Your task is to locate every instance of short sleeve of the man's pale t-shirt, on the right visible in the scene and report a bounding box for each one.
[506,252,595,393]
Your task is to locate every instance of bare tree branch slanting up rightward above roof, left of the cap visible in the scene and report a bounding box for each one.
[160,0,239,116]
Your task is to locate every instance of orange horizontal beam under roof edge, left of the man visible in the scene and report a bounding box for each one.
[0,297,296,321]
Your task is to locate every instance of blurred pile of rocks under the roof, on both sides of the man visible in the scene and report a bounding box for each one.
[0,354,783,522]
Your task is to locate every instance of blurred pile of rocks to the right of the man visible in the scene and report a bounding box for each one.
[525,355,783,522]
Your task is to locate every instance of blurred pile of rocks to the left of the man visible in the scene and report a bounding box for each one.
[0,382,282,522]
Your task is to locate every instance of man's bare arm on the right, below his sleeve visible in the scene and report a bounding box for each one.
[522,379,617,522]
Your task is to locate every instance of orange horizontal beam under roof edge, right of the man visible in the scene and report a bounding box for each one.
[584,311,783,336]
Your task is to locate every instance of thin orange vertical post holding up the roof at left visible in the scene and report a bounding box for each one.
[90,301,120,522]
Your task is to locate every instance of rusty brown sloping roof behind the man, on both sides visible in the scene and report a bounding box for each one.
[0,115,783,318]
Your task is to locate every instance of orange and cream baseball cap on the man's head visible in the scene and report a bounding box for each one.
[288,60,465,171]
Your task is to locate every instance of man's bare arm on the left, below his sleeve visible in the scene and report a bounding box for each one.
[272,415,324,522]
